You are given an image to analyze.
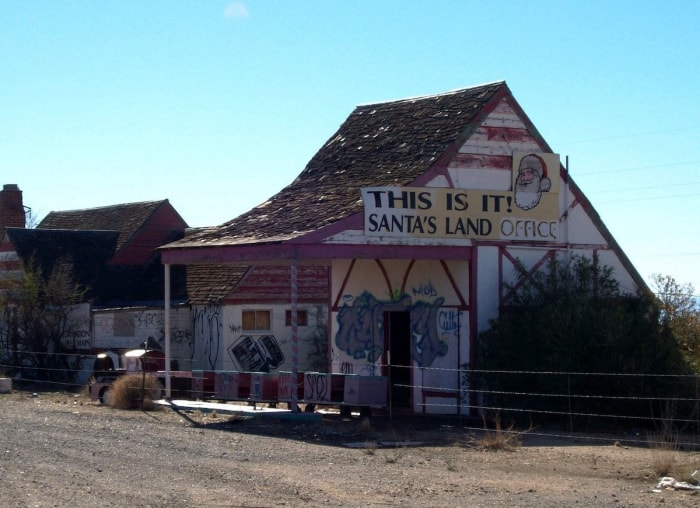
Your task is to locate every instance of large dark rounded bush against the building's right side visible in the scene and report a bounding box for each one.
[477,256,694,426]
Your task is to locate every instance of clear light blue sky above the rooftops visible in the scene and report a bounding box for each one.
[0,0,700,293]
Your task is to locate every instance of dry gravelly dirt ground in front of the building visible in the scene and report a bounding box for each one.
[0,391,700,508]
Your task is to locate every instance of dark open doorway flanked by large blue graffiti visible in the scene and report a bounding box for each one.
[384,311,412,408]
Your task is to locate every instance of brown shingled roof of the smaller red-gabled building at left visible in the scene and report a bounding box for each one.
[37,199,178,251]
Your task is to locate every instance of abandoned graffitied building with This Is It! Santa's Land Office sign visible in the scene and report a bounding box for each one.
[161,82,644,414]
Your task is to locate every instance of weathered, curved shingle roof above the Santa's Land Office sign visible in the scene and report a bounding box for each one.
[166,82,509,248]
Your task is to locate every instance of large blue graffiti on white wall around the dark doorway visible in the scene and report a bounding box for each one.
[335,286,456,367]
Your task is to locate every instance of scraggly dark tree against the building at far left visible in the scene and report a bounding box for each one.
[0,260,86,382]
